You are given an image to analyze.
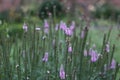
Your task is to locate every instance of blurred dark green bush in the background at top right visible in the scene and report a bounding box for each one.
[93,3,120,20]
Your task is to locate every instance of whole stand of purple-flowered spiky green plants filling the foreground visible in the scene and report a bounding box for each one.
[0,20,119,80]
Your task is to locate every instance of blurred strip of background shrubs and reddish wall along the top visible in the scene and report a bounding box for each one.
[0,0,120,22]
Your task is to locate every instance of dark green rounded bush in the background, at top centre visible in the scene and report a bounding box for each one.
[39,0,64,19]
